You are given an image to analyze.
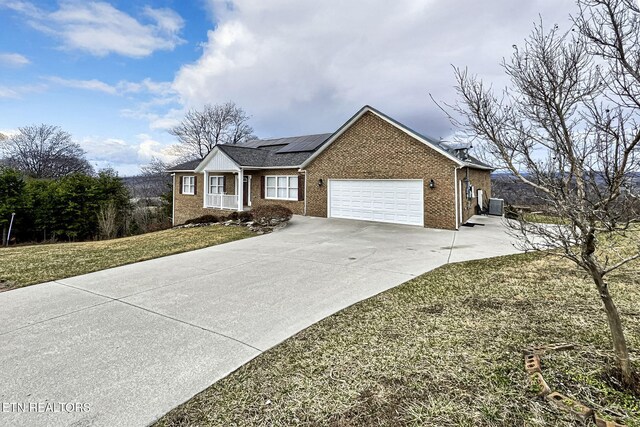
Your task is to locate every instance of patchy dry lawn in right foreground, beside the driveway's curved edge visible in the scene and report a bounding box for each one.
[157,253,640,427]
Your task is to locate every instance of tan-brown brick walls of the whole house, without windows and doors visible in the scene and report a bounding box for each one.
[174,112,491,229]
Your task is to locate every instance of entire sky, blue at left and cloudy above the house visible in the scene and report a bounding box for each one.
[0,0,575,176]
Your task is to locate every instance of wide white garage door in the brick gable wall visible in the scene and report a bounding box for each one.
[329,179,424,225]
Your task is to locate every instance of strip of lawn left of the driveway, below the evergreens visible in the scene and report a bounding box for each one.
[0,225,255,291]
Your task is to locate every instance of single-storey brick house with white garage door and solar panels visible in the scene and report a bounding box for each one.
[168,106,492,230]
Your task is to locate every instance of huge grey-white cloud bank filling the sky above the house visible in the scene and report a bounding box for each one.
[174,0,574,136]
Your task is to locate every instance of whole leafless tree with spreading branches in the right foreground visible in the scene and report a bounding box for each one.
[452,0,640,385]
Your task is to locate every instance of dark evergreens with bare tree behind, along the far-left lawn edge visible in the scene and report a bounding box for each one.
[0,124,171,245]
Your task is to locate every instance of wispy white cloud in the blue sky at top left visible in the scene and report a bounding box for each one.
[0,0,184,58]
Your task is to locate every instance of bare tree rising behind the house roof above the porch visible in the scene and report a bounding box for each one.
[169,102,253,159]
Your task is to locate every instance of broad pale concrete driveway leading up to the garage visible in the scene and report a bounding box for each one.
[0,217,517,426]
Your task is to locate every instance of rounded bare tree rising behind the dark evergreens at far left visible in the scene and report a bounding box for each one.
[0,124,93,178]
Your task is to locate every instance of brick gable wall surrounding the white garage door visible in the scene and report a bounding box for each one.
[307,112,456,229]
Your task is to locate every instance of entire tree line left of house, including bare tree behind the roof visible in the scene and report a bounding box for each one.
[0,102,255,245]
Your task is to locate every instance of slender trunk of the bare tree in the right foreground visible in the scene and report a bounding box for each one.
[589,264,633,386]
